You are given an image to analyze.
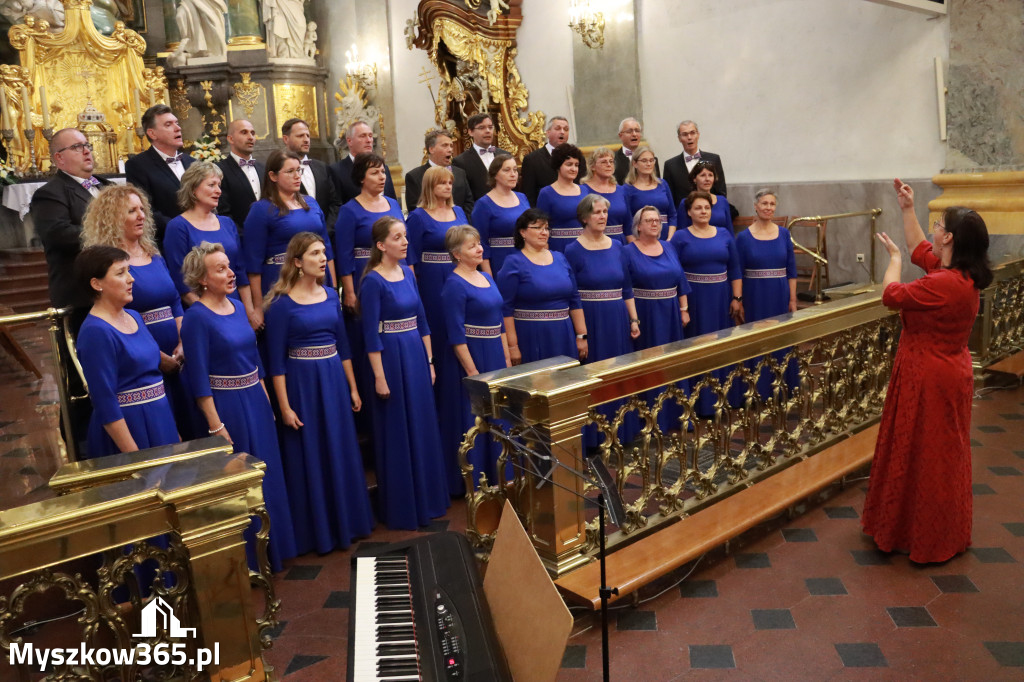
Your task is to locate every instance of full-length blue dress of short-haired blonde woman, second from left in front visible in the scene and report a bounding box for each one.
[181,296,298,571]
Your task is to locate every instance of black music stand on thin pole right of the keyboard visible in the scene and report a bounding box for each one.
[490,429,626,682]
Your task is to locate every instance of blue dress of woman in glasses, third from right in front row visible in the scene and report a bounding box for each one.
[625,242,690,431]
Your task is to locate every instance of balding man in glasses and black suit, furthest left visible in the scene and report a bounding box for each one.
[29,128,110,453]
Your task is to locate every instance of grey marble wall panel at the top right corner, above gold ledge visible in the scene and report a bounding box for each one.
[946,0,1024,170]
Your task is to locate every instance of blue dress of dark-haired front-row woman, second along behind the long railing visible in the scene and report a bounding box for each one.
[498,249,581,363]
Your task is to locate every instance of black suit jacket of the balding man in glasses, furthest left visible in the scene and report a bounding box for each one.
[29,171,111,308]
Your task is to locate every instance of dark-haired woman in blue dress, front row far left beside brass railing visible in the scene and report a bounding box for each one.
[75,246,179,458]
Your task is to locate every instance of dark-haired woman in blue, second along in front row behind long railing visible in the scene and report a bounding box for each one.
[498,208,589,365]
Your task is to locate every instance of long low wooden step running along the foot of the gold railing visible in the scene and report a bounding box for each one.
[555,424,879,610]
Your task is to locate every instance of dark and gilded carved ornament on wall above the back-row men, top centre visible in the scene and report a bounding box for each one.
[406,0,545,160]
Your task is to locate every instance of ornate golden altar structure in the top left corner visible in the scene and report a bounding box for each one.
[3,0,167,165]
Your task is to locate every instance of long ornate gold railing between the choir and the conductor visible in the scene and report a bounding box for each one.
[461,287,898,576]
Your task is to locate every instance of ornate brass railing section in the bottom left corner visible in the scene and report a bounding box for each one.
[0,438,280,681]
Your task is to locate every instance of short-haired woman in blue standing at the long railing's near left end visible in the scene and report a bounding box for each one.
[441,225,511,489]
